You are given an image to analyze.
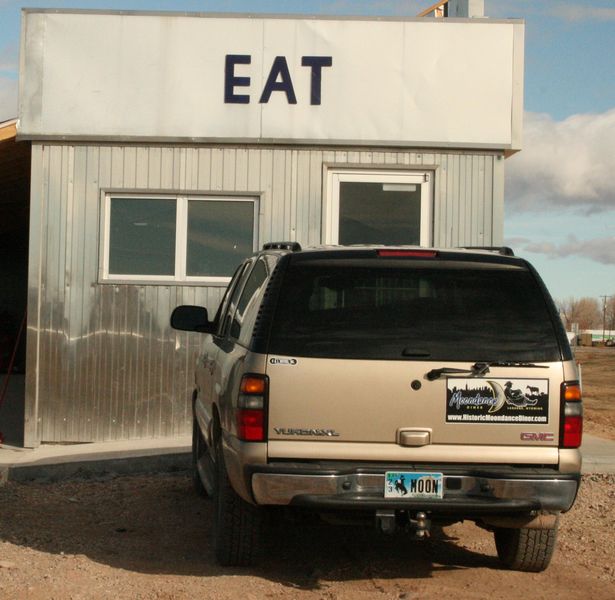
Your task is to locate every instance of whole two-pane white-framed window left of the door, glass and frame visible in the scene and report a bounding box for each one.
[99,193,258,285]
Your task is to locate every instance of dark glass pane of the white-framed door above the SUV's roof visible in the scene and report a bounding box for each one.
[339,182,421,246]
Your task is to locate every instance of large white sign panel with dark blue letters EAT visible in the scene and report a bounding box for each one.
[19,11,523,149]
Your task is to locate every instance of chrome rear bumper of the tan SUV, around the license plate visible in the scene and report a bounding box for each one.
[251,466,580,518]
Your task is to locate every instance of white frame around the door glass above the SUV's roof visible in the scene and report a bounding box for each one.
[322,168,433,247]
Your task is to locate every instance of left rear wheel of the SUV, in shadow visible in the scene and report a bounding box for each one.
[214,436,262,566]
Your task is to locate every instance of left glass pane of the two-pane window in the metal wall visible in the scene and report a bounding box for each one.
[109,198,175,276]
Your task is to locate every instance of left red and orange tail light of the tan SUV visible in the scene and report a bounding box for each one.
[235,374,269,442]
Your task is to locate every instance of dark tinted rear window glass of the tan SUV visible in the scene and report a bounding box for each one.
[270,261,559,361]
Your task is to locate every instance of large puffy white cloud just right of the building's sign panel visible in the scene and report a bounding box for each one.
[506,108,615,214]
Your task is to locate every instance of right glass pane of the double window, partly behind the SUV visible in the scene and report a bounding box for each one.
[186,200,254,277]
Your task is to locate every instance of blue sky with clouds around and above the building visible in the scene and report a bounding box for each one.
[0,0,615,302]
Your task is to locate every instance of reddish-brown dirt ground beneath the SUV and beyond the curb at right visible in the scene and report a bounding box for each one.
[0,349,615,600]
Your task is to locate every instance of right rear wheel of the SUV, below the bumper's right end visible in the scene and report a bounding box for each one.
[494,522,557,573]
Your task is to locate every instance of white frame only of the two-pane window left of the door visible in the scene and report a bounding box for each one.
[99,191,259,286]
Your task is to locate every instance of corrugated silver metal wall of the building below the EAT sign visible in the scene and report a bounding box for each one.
[25,143,504,445]
